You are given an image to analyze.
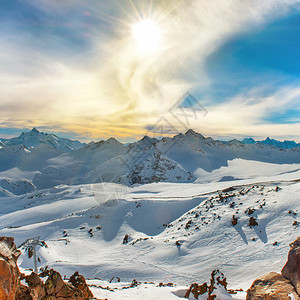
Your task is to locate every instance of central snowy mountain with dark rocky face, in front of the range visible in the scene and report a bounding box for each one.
[33,138,195,188]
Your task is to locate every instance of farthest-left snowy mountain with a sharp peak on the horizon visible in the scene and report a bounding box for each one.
[1,128,84,152]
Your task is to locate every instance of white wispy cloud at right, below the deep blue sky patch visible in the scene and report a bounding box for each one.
[171,84,300,141]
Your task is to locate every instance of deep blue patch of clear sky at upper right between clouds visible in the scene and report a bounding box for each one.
[205,11,300,100]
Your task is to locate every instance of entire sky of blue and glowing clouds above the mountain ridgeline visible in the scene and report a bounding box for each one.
[0,0,300,142]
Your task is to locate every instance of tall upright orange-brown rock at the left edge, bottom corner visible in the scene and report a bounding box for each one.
[0,237,21,300]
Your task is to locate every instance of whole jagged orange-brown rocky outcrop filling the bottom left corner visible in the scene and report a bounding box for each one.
[0,237,93,300]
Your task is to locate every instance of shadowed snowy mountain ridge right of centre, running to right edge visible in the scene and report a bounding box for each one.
[157,130,300,175]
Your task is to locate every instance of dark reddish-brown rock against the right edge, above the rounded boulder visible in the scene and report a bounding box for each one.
[281,237,300,294]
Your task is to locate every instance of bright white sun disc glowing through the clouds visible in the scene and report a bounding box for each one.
[131,19,161,54]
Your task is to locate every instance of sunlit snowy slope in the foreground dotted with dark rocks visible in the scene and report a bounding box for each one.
[0,172,300,299]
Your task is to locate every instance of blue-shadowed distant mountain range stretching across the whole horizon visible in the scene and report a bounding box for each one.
[0,128,300,195]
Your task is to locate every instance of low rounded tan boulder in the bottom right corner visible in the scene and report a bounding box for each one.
[246,272,300,300]
